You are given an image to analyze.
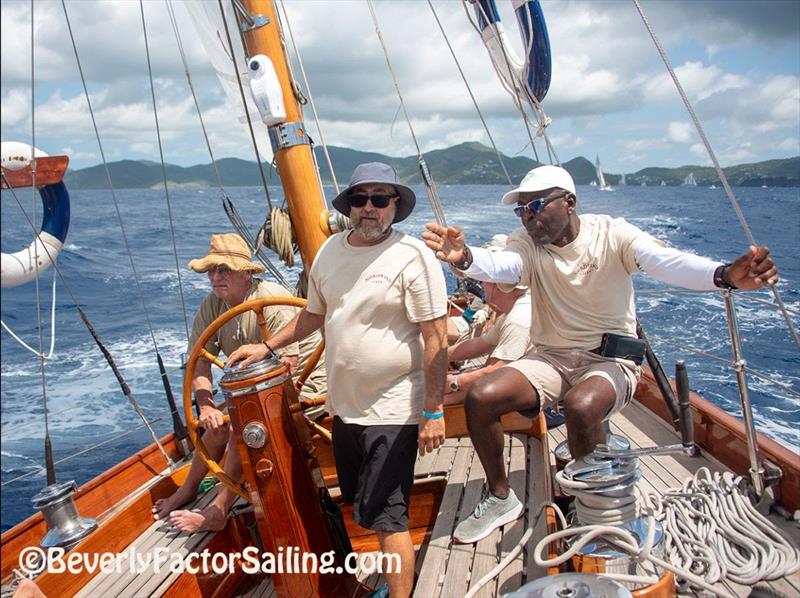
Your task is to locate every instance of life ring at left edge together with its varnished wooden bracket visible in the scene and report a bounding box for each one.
[0,141,69,287]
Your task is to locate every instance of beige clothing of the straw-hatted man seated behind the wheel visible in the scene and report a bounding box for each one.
[189,278,327,395]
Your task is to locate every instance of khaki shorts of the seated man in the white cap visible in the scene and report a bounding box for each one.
[505,349,642,418]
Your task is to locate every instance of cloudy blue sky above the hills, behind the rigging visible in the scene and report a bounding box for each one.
[0,0,800,176]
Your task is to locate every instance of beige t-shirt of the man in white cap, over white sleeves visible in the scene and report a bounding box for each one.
[502,214,657,350]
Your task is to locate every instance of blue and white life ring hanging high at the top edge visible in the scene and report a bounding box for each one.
[474,0,551,102]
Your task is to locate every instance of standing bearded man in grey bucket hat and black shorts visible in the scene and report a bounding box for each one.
[228,162,447,597]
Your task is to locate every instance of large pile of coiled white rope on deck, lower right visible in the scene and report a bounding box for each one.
[645,467,800,585]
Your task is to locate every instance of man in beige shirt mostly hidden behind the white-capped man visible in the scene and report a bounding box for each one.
[446,235,531,394]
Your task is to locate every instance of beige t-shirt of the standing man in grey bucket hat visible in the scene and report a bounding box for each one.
[306,231,447,425]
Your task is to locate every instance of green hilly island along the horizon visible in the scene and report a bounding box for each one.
[65,142,800,189]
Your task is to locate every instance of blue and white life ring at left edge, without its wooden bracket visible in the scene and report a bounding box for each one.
[0,141,69,287]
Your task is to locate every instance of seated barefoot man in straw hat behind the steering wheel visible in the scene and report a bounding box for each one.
[153,233,327,532]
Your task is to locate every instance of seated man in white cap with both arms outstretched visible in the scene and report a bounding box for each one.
[423,166,778,542]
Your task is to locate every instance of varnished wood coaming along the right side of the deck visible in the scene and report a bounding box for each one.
[635,368,800,511]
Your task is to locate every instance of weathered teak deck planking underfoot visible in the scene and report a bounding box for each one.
[73,402,800,598]
